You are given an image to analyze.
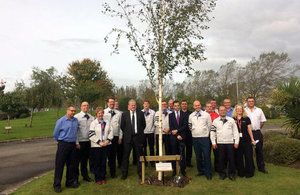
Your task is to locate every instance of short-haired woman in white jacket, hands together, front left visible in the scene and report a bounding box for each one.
[89,107,113,185]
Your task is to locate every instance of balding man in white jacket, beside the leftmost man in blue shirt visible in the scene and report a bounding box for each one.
[74,102,94,182]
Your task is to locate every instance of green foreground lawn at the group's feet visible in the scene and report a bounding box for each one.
[14,158,300,195]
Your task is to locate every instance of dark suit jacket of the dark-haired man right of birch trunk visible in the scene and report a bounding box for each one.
[169,110,188,140]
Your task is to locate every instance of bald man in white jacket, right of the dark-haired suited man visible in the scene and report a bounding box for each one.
[189,100,212,180]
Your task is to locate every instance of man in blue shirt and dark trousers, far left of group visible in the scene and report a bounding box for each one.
[53,105,79,193]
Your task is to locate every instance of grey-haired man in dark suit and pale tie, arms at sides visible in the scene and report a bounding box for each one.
[121,100,146,180]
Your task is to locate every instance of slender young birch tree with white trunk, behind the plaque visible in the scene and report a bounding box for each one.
[103,0,215,179]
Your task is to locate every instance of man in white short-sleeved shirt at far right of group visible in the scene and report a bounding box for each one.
[245,97,268,174]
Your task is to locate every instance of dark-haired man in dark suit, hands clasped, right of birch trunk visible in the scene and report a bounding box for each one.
[169,101,188,176]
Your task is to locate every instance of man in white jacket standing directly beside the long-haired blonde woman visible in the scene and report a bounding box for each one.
[210,106,239,181]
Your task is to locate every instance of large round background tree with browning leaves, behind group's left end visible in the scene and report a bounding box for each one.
[68,58,114,107]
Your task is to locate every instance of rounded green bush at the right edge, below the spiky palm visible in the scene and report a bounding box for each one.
[263,132,300,165]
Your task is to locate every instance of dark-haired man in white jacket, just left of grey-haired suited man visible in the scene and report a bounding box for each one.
[103,97,123,178]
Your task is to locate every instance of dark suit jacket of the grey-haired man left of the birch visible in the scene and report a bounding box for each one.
[121,110,146,143]
